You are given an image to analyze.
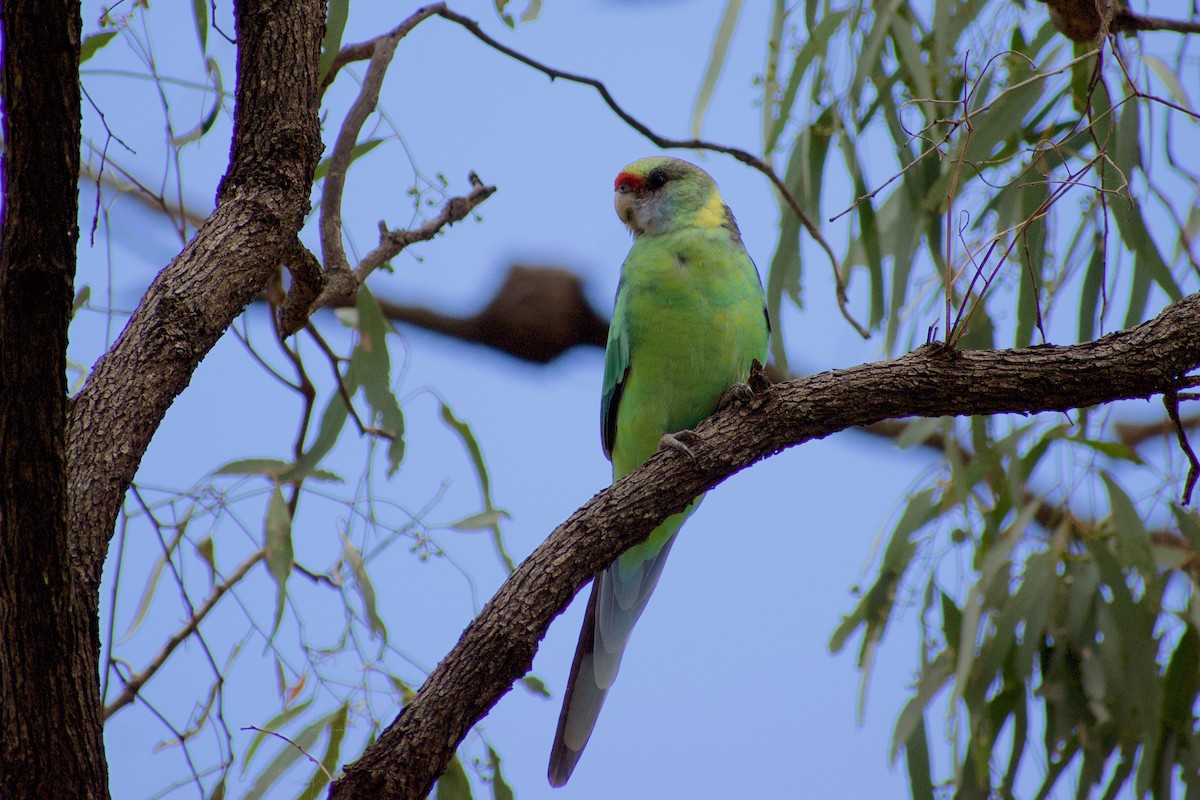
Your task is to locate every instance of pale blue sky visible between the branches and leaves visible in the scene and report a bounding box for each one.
[71,0,1185,799]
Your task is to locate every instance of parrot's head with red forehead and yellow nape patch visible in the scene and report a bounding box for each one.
[613,156,738,239]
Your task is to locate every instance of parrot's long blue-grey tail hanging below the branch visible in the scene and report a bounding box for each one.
[547,536,674,787]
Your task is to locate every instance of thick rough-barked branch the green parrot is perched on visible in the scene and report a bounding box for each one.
[330,294,1200,800]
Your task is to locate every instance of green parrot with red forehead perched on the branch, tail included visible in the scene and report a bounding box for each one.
[550,157,769,786]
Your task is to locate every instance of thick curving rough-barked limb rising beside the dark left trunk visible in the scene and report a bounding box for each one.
[67,0,324,589]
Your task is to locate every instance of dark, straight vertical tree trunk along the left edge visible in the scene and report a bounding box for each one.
[0,0,108,798]
